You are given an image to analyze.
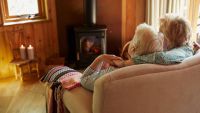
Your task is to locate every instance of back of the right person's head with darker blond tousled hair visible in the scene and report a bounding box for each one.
[159,14,192,49]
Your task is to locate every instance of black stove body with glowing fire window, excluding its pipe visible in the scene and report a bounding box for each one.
[75,25,107,67]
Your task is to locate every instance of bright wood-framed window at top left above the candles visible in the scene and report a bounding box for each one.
[1,0,47,25]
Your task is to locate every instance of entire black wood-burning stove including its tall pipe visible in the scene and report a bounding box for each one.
[68,0,107,68]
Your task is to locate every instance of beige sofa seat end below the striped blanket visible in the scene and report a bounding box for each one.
[63,87,92,113]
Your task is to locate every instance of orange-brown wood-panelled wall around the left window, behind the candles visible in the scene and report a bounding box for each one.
[0,0,59,78]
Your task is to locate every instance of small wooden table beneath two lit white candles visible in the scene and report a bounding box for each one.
[10,59,40,81]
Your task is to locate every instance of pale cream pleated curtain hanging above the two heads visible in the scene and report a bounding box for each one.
[146,0,189,30]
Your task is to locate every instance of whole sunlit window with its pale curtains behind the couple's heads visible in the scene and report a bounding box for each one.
[146,0,200,43]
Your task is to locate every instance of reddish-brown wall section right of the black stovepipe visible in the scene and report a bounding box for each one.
[97,0,122,55]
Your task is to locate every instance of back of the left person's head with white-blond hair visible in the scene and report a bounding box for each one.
[128,23,163,57]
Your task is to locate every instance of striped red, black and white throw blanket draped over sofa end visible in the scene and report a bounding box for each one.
[41,66,82,113]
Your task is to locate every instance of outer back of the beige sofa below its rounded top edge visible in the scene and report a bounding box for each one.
[93,64,200,113]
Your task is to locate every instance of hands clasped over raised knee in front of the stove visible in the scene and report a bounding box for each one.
[90,54,122,69]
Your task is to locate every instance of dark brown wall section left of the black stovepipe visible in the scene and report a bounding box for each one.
[56,0,84,57]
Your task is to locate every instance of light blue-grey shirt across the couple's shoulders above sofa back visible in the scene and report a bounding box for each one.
[132,46,193,65]
